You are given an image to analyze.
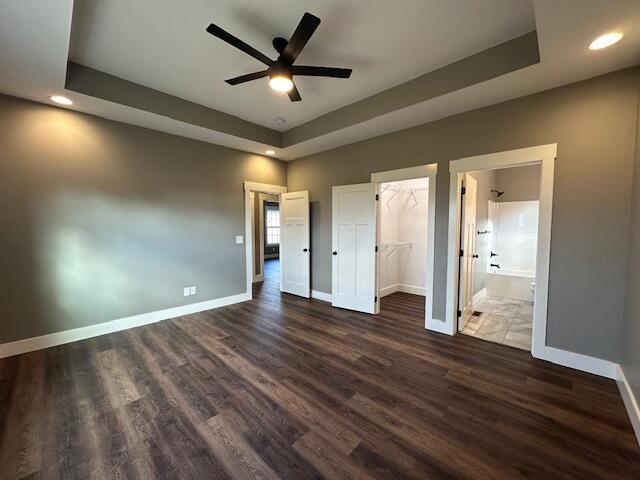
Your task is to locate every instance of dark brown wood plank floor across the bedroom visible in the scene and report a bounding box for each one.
[0,262,640,480]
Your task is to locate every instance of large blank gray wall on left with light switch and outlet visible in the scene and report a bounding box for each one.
[0,96,286,343]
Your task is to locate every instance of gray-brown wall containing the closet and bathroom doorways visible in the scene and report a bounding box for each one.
[287,68,639,361]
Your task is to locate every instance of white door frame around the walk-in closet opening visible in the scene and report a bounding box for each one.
[371,163,442,330]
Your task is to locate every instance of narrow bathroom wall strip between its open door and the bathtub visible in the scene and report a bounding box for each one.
[469,170,496,295]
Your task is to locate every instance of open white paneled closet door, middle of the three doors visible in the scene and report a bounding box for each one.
[331,183,377,313]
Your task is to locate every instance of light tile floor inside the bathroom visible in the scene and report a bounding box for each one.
[461,297,533,350]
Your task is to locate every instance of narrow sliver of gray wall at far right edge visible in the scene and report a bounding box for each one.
[620,79,640,399]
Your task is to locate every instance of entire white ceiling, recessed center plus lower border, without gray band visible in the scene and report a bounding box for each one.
[0,0,640,159]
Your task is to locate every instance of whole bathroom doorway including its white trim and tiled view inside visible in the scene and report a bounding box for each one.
[446,145,556,357]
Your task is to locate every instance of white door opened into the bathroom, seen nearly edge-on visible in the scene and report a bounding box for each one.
[459,173,478,329]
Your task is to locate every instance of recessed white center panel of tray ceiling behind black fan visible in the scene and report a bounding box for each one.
[70,0,535,129]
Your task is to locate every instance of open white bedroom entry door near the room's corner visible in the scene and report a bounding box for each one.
[280,191,311,298]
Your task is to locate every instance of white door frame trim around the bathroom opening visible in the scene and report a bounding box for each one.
[440,143,558,358]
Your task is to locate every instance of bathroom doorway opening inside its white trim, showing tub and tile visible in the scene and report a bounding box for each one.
[458,165,540,350]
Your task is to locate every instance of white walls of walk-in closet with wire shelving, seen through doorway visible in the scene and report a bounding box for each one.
[379,178,429,297]
